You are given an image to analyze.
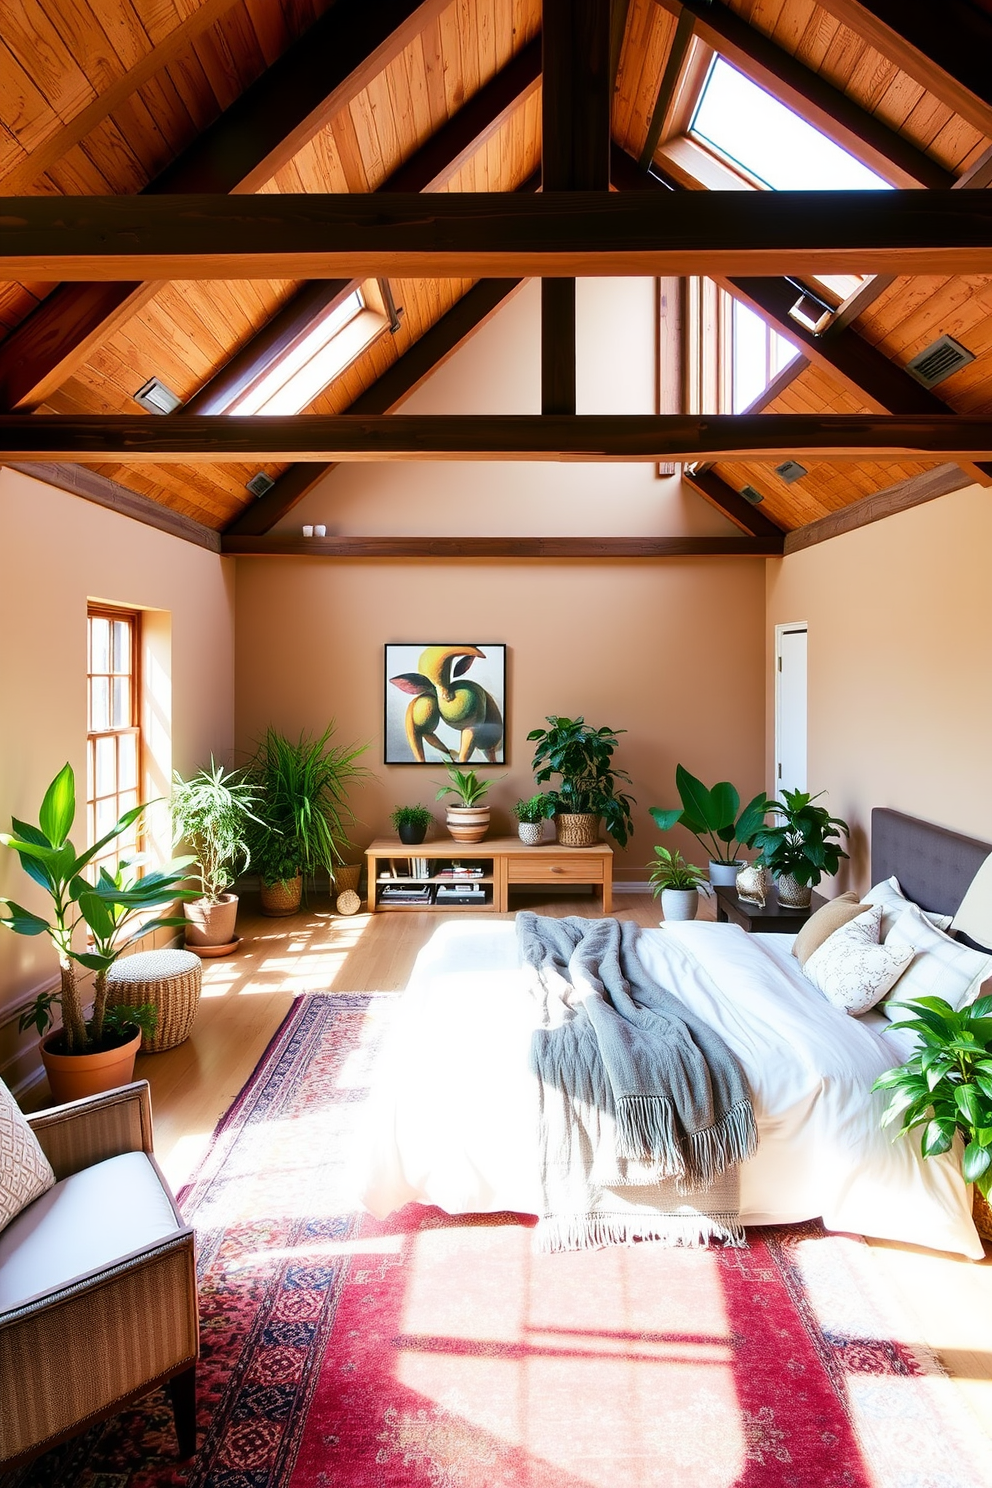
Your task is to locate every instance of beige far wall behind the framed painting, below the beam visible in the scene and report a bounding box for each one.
[236,558,764,879]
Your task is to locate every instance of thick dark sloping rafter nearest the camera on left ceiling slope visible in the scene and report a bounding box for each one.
[0,0,443,409]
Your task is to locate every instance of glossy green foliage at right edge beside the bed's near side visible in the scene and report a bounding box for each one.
[875,997,992,1199]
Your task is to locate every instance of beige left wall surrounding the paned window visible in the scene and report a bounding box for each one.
[0,469,233,1082]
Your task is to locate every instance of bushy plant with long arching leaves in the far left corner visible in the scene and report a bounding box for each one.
[248,723,369,915]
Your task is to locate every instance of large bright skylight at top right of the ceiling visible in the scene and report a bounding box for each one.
[689,57,891,190]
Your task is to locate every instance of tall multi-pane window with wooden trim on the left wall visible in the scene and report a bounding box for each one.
[86,606,141,869]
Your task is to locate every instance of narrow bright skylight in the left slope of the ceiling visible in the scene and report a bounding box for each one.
[228,290,390,415]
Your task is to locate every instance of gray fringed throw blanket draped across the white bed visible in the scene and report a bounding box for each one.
[516,914,757,1250]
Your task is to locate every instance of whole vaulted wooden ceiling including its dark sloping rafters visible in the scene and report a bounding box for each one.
[0,0,992,553]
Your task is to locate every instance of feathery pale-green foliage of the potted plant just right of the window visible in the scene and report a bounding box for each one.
[173,754,259,905]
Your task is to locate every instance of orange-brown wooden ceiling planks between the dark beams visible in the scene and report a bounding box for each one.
[0,0,992,531]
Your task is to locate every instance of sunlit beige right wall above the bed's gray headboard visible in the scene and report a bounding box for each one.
[766,487,992,890]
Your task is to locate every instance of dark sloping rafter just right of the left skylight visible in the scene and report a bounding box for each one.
[226,280,521,537]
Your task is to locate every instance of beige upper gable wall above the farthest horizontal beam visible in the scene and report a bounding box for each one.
[275,280,738,537]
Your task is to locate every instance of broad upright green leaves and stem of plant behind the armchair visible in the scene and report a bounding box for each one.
[0,765,196,1054]
